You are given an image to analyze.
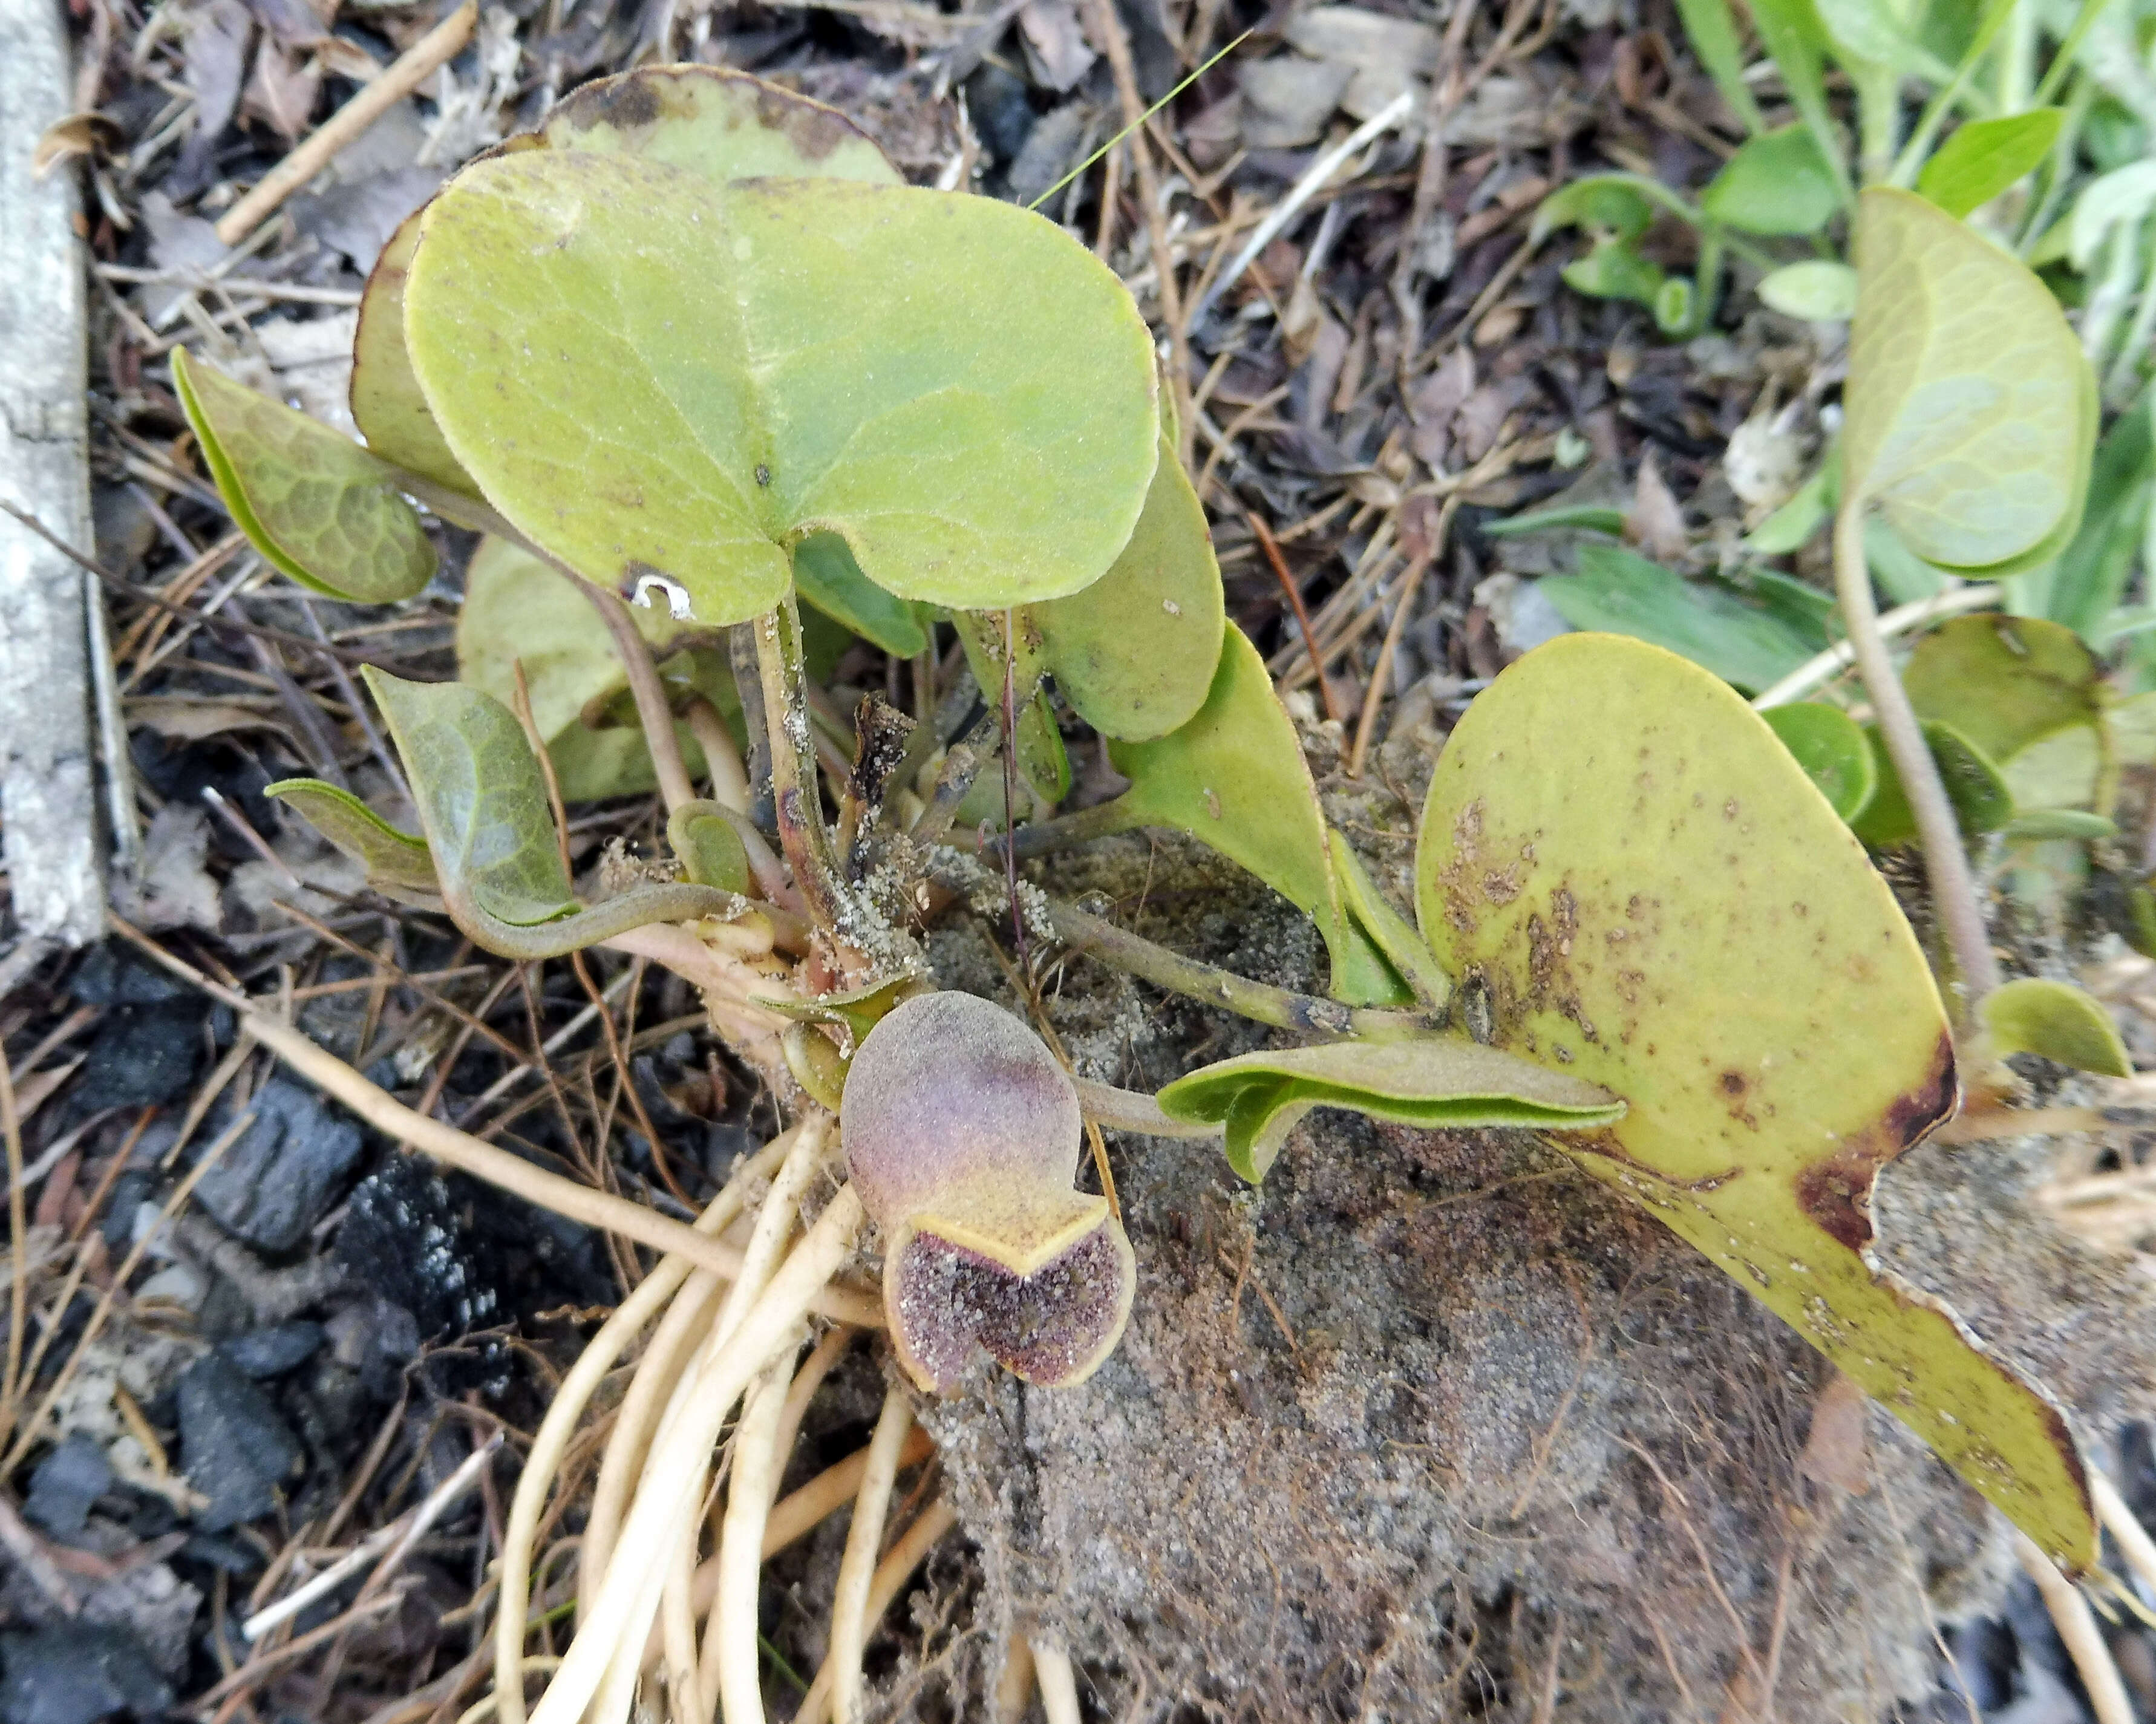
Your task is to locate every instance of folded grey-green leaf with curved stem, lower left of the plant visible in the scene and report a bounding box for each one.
[360,664,739,959]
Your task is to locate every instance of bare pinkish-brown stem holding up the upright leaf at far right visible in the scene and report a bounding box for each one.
[1835,495,1999,1017]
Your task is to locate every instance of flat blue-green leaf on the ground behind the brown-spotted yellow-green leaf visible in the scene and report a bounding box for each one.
[1541,545,1815,694]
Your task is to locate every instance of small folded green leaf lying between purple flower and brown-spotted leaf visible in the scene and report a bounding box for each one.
[1158,1037,1624,1185]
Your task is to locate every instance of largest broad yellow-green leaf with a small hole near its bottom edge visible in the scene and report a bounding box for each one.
[405,151,1158,625]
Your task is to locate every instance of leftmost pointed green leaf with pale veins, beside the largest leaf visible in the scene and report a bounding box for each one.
[172,347,433,606]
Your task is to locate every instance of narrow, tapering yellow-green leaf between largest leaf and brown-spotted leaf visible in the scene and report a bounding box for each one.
[1100,623,1414,1007]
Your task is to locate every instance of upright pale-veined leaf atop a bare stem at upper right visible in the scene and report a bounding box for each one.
[1841,185,2096,569]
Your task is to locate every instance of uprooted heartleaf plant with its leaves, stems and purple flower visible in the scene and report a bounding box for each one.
[175,67,2094,1586]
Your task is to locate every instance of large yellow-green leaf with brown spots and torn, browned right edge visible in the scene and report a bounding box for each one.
[1417,636,2096,1569]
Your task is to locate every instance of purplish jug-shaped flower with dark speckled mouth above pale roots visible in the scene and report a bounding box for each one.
[838,993,1136,1394]
